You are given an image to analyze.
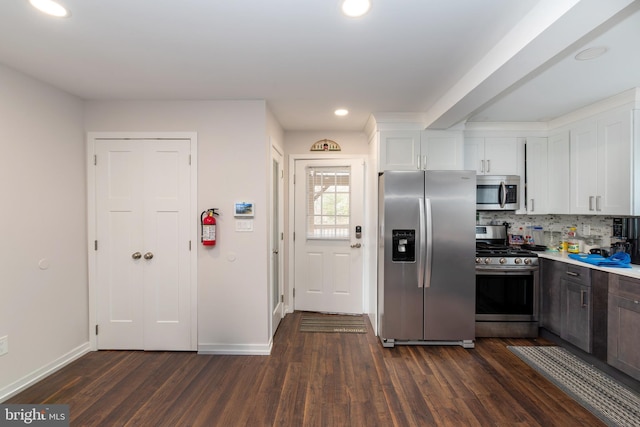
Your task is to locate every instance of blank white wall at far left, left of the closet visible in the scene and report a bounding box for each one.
[0,65,89,401]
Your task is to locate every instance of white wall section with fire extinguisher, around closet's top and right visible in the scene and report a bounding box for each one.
[85,101,278,354]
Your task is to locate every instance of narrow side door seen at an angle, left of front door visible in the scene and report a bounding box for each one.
[270,147,284,336]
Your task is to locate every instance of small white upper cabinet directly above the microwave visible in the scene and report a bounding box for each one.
[464,137,523,175]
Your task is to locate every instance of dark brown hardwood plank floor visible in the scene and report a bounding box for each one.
[4,312,604,426]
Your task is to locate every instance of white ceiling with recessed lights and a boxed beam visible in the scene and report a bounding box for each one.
[0,0,640,130]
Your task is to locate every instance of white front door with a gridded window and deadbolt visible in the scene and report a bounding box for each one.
[294,159,364,314]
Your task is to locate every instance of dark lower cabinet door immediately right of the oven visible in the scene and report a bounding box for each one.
[540,259,566,335]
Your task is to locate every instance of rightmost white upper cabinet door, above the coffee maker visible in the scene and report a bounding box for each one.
[596,111,632,215]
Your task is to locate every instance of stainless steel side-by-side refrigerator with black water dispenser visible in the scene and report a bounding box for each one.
[378,171,476,348]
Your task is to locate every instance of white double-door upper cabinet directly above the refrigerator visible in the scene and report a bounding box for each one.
[378,130,463,172]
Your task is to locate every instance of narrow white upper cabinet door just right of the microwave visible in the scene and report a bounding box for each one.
[525,138,549,215]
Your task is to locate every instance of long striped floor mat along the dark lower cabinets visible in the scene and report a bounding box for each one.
[507,346,640,426]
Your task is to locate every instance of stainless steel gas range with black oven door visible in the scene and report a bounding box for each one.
[476,225,540,338]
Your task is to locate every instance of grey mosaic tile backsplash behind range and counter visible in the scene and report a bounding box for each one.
[477,211,618,248]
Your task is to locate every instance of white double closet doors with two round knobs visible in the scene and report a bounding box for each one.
[95,140,192,350]
